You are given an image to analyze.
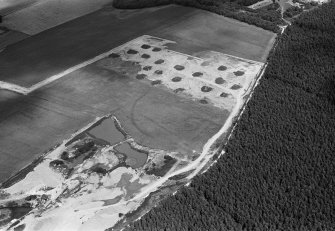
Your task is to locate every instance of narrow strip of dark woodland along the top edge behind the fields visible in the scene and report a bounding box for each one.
[113,0,283,33]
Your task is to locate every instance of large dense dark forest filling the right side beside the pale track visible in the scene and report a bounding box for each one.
[129,1,335,231]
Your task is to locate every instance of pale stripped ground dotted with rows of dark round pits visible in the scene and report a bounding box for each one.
[99,36,264,111]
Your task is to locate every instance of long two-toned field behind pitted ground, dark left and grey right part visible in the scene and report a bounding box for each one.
[0,5,275,87]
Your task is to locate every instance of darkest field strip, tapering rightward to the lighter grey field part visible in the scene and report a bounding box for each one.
[0,6,196,87]
